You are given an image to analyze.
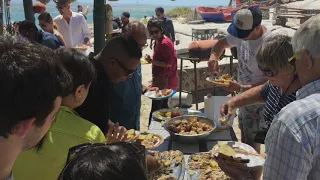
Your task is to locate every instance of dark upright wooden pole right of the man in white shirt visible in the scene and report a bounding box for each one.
[93,0,106,54]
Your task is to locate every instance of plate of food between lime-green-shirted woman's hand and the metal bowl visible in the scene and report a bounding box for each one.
[126,129,164,149]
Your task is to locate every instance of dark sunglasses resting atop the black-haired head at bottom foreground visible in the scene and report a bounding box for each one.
[58,142,147,180]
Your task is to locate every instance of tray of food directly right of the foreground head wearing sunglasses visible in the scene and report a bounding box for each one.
[148,150,185,180]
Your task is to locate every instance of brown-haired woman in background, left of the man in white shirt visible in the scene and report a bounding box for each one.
[38,12,66,46]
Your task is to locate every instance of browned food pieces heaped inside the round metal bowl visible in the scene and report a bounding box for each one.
[168,117,213,135]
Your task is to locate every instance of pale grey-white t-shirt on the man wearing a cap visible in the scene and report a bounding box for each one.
[226,28,271,84]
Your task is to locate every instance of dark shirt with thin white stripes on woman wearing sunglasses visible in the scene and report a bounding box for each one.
[261,81,296,129]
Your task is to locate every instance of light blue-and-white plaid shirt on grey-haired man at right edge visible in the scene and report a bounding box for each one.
[263,80,320,180]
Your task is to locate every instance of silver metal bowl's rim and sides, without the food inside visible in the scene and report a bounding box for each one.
[164,115,216,143]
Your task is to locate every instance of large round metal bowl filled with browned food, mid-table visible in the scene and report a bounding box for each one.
[164,115,216,143]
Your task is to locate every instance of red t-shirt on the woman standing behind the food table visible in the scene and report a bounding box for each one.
[152,37,178,90]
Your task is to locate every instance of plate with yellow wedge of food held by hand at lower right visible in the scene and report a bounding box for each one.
[211,141,265,168]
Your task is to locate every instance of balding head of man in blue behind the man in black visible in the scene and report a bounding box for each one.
[124,21,149,46]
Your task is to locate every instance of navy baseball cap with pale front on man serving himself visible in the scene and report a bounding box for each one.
[228,6,262,39]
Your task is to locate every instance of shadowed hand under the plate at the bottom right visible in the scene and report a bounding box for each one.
[216,156,263,180]
